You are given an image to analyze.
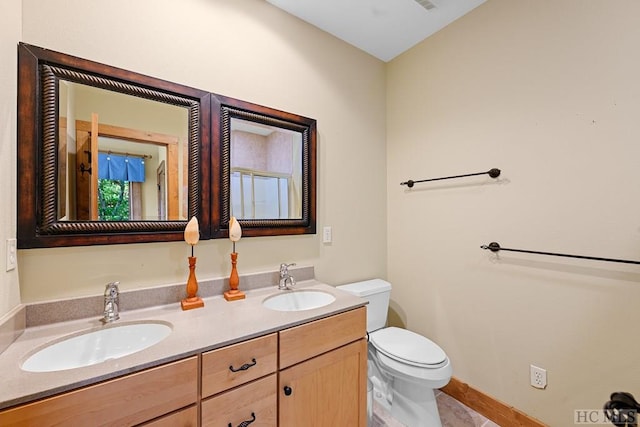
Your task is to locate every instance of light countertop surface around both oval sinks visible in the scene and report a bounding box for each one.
[0,280,366,409]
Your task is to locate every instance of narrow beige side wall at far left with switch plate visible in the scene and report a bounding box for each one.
[0,0,22,317]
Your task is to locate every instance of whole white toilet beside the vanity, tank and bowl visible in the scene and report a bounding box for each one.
[336,279,452,427]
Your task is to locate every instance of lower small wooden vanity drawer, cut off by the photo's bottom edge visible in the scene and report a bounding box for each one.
[202,374,278,427]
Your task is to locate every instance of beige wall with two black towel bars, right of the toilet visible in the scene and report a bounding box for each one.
[387,0,640,426]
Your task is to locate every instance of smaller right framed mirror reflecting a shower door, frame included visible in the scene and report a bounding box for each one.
[211,95,316,237]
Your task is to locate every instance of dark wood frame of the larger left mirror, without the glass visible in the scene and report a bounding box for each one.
[17,43,211,248]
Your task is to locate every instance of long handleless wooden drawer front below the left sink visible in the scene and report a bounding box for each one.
[0,356,198,427]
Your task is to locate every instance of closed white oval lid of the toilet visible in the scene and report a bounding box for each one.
[370,327,447,368]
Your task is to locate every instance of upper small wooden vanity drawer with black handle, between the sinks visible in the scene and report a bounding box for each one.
[202,333,278,398]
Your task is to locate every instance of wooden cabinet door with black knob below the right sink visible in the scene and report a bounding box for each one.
[278,339,367,427]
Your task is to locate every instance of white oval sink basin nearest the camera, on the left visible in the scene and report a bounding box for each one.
[22,322,172,372]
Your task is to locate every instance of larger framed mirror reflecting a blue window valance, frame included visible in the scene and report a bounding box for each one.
[18,43,211,248]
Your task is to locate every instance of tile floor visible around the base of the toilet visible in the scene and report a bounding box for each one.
[370,390,500,427]
